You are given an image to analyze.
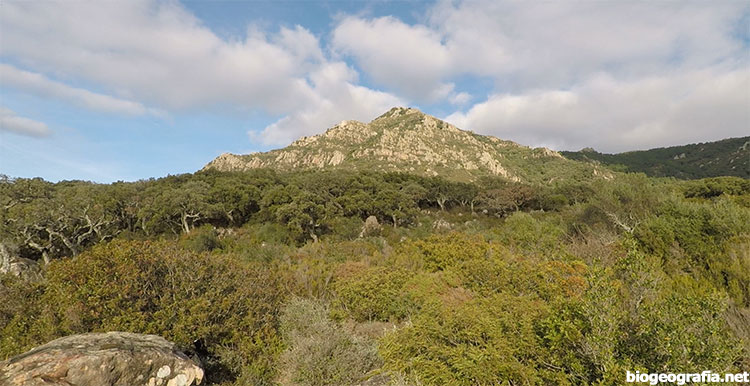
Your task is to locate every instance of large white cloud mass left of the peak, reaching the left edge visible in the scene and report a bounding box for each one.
[0,0,406,144]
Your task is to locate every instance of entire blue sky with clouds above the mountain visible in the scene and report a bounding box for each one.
[0,0,750,182]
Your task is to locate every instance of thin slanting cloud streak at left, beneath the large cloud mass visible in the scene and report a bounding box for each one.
[0,63,165,116]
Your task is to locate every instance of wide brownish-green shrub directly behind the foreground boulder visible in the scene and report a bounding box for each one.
[5,241,283,384]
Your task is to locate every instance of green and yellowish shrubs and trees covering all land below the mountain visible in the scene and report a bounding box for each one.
[0,169,750,385]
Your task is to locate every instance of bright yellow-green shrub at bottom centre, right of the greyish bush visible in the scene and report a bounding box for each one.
[379,294,550,385]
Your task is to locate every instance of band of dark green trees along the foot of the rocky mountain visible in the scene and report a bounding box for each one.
[0,170,612,262]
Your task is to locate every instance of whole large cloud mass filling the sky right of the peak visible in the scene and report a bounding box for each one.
[332,0,750,151]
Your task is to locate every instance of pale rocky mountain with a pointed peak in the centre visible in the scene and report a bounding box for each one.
[204,107,612,183]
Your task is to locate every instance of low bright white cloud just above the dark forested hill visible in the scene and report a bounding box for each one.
[446,69,750,152]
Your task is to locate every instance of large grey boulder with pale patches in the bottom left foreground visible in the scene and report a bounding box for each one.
[0,332,203,386]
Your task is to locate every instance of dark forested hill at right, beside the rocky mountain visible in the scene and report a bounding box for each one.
[561,137,750,179]
